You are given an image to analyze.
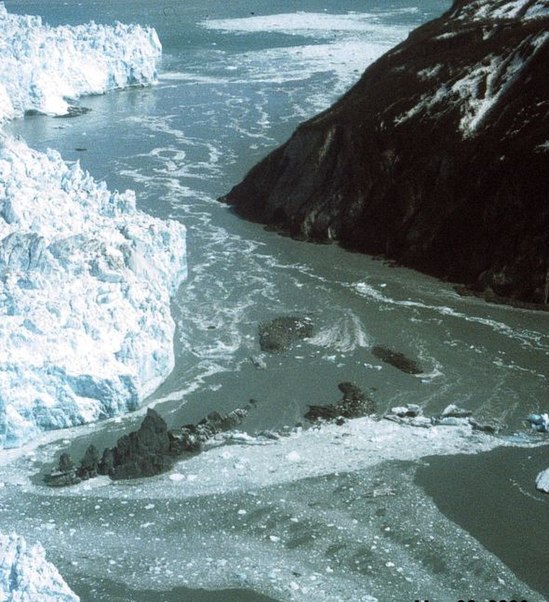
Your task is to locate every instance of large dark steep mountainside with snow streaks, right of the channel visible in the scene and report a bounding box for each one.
[222,0,549,305]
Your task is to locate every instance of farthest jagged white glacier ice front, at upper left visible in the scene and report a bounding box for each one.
[0,2,162,123]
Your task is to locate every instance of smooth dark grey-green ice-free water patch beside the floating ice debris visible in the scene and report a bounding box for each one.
[417,447,549,598]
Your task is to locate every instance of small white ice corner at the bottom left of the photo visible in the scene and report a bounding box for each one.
[0,533,80,602]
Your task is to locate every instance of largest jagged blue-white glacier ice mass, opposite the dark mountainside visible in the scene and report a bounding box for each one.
[0,138,186,448]
